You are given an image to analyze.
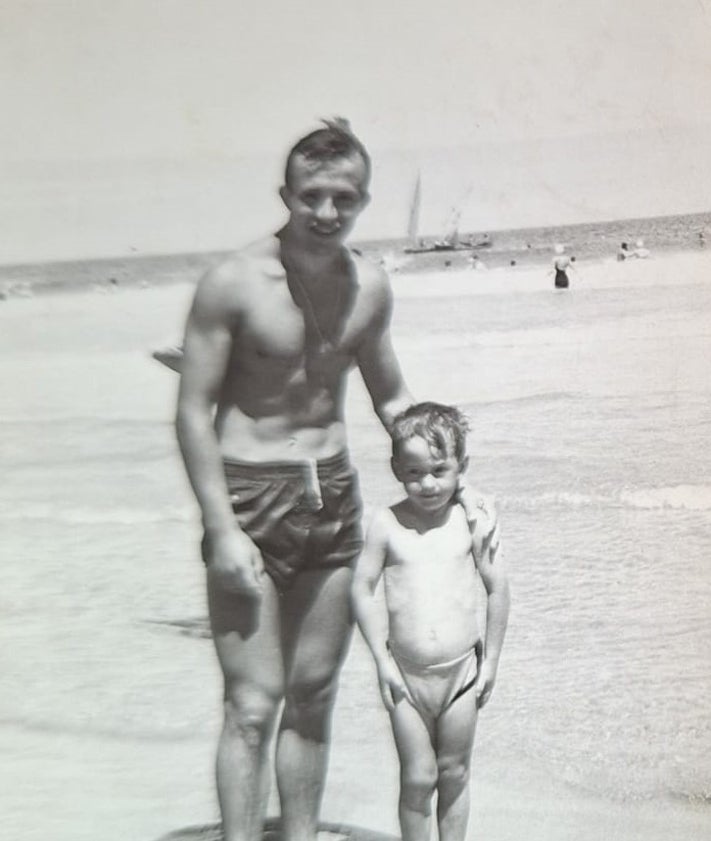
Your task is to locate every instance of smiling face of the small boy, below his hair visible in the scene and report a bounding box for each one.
[392,437,466,514]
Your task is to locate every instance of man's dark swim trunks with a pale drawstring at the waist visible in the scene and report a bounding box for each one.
[202,453,363,591]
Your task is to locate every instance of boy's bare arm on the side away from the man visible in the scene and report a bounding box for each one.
[472,516,511,707]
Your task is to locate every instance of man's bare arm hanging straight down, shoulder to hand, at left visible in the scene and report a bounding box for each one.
[175,268,262,595]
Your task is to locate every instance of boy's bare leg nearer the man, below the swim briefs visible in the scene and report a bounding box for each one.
[390,698,437,841]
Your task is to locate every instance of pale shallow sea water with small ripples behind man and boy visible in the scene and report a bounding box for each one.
[0,256,711,832]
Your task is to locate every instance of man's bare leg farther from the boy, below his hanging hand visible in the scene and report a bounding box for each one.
[208,575,284,841]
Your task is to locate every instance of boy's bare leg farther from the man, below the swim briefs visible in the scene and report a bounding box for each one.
[436,687,477,841]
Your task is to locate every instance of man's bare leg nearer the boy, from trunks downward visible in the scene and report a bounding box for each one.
[276,567,353,841]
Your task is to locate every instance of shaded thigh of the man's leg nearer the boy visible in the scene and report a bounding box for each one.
[281,567,353,694]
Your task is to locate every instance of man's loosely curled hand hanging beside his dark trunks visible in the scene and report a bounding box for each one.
[206,529,264,601]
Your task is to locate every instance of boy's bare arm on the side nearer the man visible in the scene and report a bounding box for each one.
[351,511,409,710]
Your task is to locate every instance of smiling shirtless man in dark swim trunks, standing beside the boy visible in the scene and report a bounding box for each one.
[176,121,413,841]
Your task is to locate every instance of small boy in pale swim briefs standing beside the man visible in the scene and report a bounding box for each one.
[353,403,509,841]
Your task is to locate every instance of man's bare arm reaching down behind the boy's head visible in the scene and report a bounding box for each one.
[357,281,415,431]
